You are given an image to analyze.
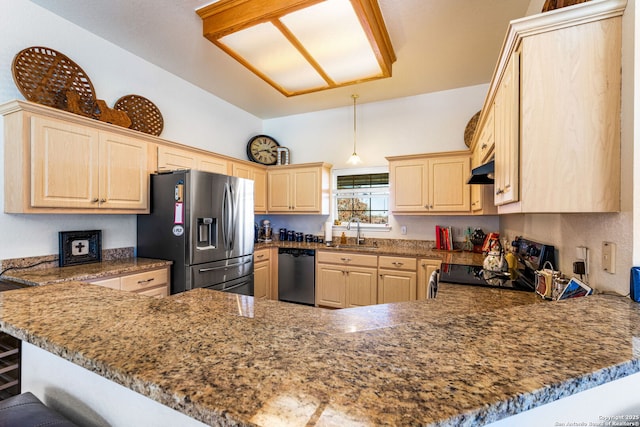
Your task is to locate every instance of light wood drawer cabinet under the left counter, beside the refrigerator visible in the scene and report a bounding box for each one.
[89,267,171,297]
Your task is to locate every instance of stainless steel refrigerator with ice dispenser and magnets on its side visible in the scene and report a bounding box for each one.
[136,170,255,295]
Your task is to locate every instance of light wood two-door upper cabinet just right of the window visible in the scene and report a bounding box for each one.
[387,151,471,215]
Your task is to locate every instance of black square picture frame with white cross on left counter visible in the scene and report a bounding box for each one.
[58,230,102,267]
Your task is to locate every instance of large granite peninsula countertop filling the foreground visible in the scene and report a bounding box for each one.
[0,282,640,426]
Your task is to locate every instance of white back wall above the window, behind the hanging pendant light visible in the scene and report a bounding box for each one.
[263,84,488,168]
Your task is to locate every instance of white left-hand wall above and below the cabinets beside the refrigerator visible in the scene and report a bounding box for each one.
[0,0,262,259]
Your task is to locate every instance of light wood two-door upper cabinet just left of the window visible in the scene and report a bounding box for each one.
[267,163,331,215]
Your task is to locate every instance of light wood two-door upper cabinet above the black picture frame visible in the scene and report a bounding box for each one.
[0,101,152,214]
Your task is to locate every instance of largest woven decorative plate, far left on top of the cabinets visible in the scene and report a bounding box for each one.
[11,46,96,117]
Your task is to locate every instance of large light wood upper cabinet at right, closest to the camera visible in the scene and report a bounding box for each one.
[472,0,626,213]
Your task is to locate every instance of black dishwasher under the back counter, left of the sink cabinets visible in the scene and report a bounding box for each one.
[278,248,316,305]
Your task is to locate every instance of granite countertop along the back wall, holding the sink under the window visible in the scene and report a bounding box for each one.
[255,239,484,265]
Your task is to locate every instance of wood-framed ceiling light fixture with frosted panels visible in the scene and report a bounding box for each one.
[196,0,396,96]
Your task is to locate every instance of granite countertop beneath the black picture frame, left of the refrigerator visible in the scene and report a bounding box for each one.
[2,258,173,286]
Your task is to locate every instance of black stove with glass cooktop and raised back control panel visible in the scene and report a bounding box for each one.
[438,237,556,292]
